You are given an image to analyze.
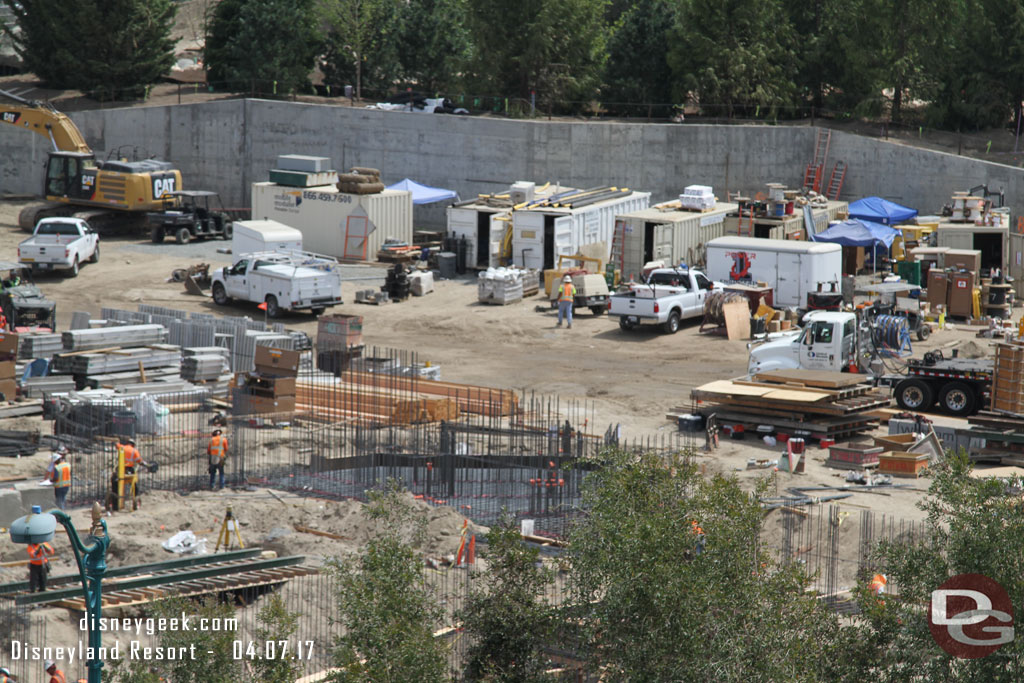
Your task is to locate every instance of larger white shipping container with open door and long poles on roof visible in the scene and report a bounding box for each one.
[512,193,650,270]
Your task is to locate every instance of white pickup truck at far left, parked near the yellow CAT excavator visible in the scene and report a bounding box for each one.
[17,218,99,276]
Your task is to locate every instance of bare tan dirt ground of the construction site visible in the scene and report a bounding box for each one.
[0,197,1007,663]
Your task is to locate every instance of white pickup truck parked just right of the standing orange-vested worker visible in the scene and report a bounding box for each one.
[608,268,725,334]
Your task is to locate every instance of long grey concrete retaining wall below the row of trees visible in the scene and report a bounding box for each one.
[0,99,1024,226]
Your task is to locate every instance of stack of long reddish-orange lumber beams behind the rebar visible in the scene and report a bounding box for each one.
[296,382,459,424]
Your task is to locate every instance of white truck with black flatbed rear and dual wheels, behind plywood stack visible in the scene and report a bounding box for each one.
[748,309,994,417]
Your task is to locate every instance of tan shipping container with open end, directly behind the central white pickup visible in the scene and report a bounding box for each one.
[615,202,737,278]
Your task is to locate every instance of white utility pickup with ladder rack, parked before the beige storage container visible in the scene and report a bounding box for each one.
[211,252,341,317]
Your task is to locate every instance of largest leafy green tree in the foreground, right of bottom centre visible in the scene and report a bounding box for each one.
[567,451,841,681]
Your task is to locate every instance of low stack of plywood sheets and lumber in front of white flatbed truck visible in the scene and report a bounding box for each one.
[692,370,890,439]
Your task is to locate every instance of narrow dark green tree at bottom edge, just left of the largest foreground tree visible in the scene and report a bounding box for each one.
[460,516,552,683]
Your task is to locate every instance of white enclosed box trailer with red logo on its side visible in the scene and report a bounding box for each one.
[707,237,843,308]
